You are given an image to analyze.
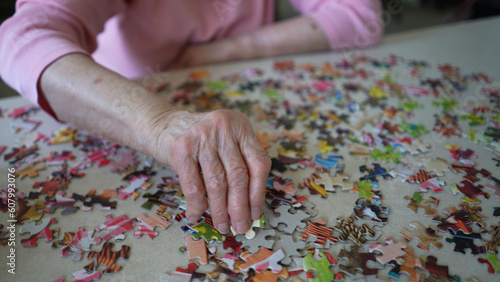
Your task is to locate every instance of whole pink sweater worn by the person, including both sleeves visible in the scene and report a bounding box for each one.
[0,0,383,112]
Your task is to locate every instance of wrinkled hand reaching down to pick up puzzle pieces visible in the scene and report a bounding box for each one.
[143,110,271,233]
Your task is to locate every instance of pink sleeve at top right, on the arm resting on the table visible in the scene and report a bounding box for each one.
[289,0,384,50]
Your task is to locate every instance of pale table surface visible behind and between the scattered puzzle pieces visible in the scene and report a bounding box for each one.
[0,17,500,281]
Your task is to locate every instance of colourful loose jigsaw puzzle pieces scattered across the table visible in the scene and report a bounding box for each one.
[0,55,500,281]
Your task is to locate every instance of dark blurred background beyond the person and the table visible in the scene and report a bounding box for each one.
[0,0,500,97]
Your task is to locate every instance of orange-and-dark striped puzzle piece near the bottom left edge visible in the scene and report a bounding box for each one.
[85,242,130,273]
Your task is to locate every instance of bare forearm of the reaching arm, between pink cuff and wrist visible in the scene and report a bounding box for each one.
[40,54,180,153]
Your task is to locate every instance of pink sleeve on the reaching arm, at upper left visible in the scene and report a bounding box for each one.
[0,0,126,114]
